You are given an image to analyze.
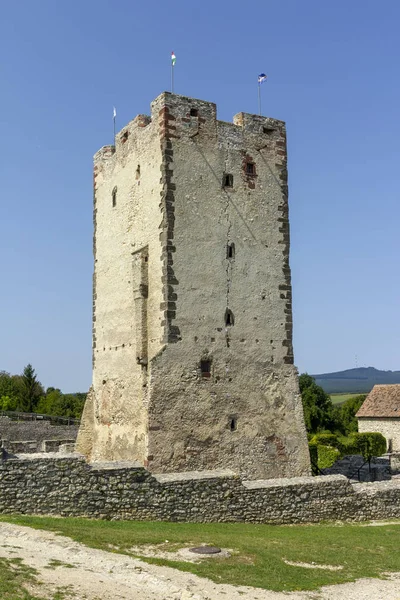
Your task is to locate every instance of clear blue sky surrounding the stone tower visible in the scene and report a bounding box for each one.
[0,0,400,392]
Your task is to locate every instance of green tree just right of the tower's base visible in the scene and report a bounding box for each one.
[299,373,336,433]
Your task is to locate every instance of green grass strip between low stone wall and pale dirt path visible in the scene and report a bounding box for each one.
[0,516,400,600]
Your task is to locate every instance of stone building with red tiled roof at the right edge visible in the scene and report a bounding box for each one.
[356,384,400,452]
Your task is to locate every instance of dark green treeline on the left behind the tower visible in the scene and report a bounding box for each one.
[0,364,86,419]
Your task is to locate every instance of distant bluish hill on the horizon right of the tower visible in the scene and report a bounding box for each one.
[312,367,400,394]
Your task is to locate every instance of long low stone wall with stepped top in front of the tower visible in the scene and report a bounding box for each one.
[0,454,400,524]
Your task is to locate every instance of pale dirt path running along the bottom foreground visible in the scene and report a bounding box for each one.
[0,523,400,600]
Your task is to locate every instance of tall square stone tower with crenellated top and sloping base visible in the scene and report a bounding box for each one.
[77,92,309,479]
